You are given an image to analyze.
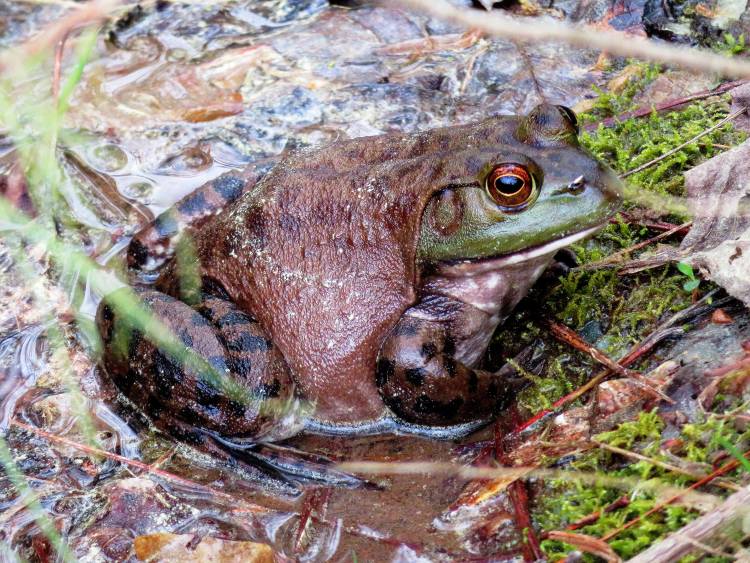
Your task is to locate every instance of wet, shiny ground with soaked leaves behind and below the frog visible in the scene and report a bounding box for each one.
[0,0,750,561]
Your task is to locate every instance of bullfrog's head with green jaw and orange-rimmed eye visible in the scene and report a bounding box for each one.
[418,104,622,264]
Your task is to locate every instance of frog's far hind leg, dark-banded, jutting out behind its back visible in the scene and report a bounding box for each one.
[128,158,278,270]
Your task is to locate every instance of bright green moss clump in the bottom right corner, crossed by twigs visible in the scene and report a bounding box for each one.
[534,413,750,561]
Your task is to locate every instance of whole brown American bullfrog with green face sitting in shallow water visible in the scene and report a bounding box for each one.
[97,104,621,450]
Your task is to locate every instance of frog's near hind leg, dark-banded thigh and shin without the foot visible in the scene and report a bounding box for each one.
[97,290,293,436]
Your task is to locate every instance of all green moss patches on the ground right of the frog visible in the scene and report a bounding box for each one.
[512,67,750,561]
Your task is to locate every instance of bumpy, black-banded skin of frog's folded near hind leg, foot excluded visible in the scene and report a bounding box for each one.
[97,290,294,444]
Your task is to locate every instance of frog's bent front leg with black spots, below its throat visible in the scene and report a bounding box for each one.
[376,295,517,426]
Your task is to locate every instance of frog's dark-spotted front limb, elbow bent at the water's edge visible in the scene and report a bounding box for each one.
[376,305,512,425]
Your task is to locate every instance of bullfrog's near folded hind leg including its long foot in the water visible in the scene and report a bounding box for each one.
[97,290,374,488]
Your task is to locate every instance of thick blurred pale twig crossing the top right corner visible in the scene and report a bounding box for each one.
[399,0,750,78]
